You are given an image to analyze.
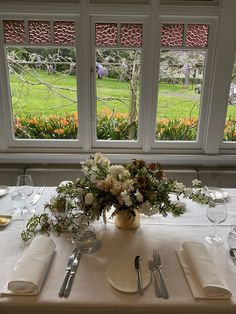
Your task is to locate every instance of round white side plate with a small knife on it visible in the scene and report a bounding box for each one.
[106,257,151,293]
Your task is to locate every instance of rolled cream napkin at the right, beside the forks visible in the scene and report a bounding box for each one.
[177,242,232,299]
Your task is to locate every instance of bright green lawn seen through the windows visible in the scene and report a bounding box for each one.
[10,70,236,119]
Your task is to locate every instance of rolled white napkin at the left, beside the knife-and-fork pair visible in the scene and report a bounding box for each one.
[3,235,56,295]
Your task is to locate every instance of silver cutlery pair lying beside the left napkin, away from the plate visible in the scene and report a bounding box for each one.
[58,247,81,297]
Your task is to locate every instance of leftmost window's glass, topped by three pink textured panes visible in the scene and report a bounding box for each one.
[3,19,79,147]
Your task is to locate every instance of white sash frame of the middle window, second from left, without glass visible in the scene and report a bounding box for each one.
[90,15,148,149]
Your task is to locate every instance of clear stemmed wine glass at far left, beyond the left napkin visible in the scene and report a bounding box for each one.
[16,174,34,213]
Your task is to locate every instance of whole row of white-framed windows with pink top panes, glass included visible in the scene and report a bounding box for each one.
[0,0,236,163]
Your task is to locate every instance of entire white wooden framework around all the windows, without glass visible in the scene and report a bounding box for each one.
[0,0,236,166]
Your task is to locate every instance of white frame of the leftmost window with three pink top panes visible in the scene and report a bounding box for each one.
[0,14,84,149]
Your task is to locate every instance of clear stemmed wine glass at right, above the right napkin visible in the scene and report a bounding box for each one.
[205,199,227,246]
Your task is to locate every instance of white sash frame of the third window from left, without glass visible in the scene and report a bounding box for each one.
[150,15,217,150]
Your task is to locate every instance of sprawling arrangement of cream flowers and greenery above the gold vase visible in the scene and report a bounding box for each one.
[22,153,214,241]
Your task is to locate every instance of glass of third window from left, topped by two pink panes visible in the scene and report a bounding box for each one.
[156,23,209,141]
